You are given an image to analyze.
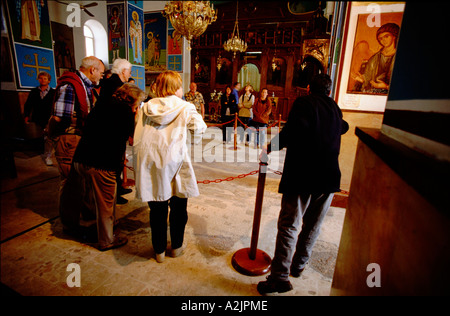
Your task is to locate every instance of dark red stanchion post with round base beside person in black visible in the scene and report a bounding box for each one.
[231,163,272,276]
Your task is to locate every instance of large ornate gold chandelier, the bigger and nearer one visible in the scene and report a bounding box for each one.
[162,1,217,50]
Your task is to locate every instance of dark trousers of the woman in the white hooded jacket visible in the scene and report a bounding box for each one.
[148,196,188,254]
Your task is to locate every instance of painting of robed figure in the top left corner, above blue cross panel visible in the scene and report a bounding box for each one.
[7,0,52,49]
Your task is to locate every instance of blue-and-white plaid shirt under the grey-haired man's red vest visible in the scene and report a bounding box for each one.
[53,71,94,118]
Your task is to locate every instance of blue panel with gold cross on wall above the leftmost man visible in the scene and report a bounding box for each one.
[15,43,56,88]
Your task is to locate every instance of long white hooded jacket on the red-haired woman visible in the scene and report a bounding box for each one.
[133,95,207,202]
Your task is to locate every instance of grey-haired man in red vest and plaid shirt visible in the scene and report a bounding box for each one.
[48,56,105,235]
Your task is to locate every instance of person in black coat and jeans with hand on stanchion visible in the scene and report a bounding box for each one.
[257,74,349,294]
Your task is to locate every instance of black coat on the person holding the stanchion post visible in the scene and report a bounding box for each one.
[268,94,349,194]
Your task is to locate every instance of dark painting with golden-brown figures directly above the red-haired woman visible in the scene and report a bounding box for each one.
[144,12,167,72]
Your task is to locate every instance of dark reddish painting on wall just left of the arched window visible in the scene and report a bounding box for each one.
[52,22,76,75]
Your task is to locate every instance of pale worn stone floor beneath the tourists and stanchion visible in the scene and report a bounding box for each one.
[0,133,345,296]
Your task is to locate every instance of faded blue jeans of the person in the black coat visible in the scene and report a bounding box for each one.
[270,193,334,281]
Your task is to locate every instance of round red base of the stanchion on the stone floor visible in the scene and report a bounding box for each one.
[231,248,272,276]
